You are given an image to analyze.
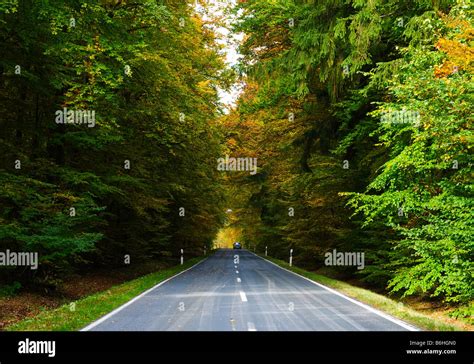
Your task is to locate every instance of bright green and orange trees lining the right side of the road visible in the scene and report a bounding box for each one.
[226,0,474,303]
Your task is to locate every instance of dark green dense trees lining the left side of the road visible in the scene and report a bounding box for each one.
[0,0,227,284]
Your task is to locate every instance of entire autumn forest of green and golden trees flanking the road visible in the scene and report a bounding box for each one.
[0,0,474,328]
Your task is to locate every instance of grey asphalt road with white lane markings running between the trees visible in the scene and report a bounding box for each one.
[83,249,414,331]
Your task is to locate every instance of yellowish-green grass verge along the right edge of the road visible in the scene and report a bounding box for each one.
[262,256,470,331]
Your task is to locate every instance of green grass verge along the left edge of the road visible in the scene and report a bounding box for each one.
[5,257,204,331]
